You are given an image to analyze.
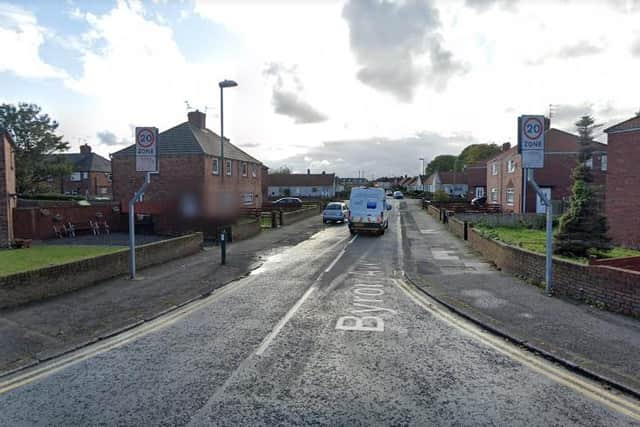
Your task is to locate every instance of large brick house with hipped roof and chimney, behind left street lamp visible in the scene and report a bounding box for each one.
[111,111,267,234]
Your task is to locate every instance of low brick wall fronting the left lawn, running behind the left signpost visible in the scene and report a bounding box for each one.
[0,233,202,309]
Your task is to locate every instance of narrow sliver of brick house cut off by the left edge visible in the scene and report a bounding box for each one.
[0,129,16,248]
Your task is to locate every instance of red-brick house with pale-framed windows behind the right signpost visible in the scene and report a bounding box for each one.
[487,129,607,213]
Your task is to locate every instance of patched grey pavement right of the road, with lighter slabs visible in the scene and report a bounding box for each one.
[403,201,640,396]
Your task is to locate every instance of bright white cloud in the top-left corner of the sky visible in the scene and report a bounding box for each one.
[0,3,66,78]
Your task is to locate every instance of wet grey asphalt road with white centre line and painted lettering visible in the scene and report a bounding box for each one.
[0,202,640,426]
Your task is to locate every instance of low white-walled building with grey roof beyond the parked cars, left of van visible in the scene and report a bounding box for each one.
[267,170,336,199]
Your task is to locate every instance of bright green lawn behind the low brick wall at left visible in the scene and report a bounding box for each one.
[0,245,123,276]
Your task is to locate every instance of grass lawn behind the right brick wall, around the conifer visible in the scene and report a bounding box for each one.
[475,226,640,262]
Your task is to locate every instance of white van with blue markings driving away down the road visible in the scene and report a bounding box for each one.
[349,188,391,234]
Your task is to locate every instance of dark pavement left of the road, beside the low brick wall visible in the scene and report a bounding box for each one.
[0,217,336,377]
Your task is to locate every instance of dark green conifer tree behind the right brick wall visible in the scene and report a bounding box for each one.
[554,116,611,257]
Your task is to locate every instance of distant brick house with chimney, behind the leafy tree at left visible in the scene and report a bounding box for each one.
[47,144,111,197]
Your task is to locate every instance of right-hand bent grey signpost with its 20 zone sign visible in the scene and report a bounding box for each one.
[518,116,553,295]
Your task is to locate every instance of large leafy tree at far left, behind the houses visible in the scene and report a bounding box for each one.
[0,103,69,193]
